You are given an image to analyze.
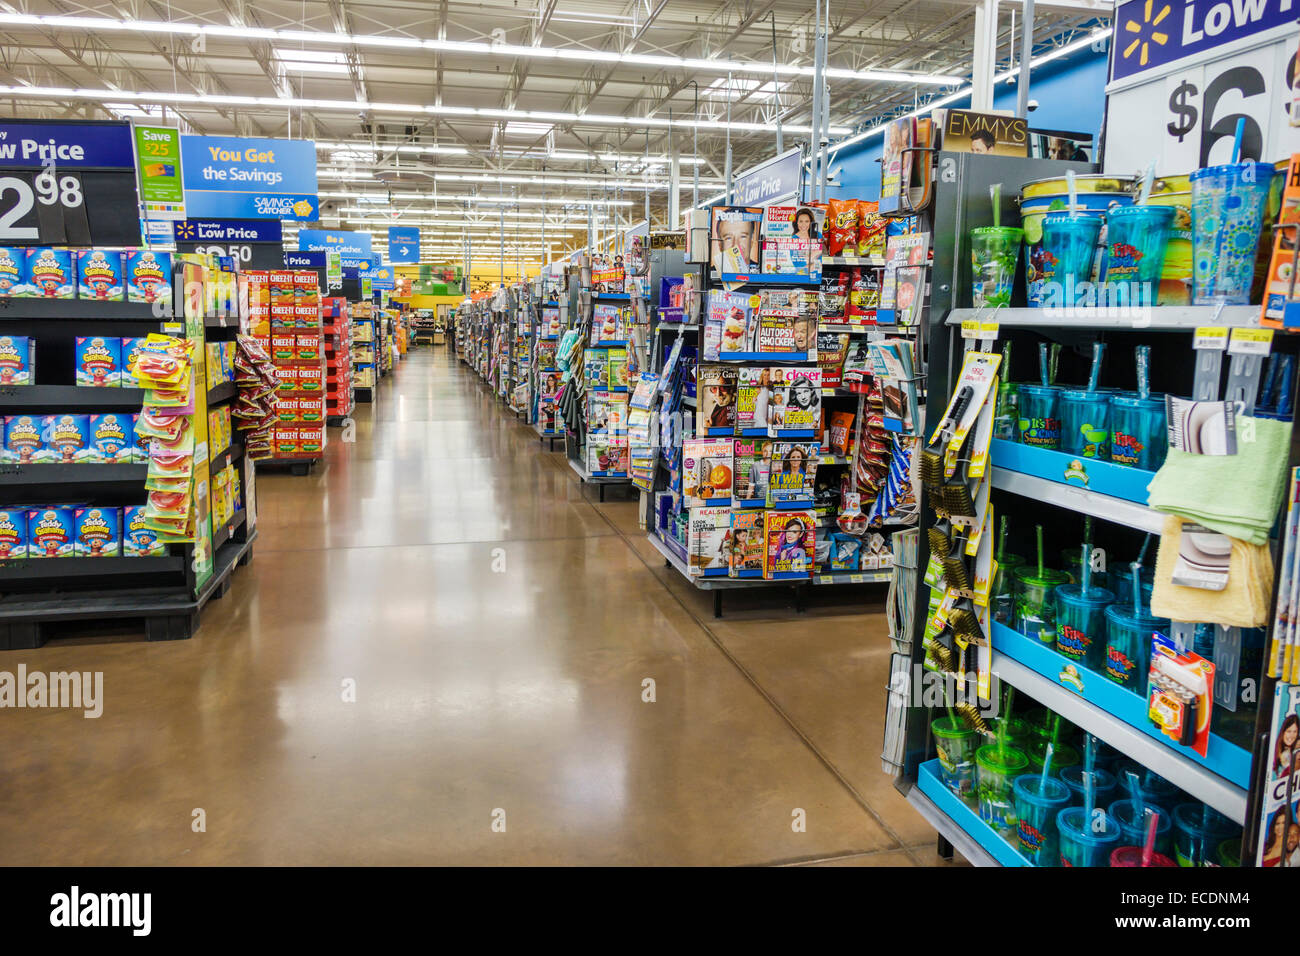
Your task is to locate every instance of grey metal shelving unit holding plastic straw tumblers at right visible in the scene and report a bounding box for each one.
[897,153,1266,865]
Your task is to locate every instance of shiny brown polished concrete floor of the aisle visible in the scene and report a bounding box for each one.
[0,349,937,866]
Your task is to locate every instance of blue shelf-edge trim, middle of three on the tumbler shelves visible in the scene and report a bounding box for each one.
[992,622,1251,790]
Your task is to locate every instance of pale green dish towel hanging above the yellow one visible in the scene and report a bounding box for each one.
[1147,415,1291,545]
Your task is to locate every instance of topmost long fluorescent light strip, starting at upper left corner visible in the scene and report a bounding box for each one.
[0,13,966,86]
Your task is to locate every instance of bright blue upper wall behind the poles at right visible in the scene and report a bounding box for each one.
[827,49,1108,200]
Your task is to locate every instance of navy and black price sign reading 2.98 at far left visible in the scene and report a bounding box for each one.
[0,120,140,246]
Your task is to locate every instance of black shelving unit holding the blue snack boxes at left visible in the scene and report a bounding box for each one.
[0,268,256,650]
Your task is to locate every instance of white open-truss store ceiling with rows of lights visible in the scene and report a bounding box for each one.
[0,0,1112,260]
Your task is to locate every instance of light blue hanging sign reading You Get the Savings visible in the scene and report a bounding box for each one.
[181,137,320,221]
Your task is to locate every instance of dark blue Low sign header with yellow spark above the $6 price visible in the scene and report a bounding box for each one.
[1112,0,1300,79]
